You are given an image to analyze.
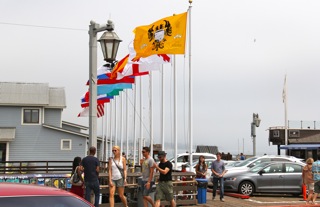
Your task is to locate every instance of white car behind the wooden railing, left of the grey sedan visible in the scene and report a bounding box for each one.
[168,152,217,171]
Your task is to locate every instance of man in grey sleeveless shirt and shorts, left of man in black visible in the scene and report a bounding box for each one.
[140,147,155,207]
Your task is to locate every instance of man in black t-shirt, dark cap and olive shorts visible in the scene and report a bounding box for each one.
[154,151,176,207]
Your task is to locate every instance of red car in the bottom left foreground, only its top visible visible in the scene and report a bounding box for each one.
[0,183,94,207]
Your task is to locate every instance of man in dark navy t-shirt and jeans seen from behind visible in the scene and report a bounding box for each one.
[82,146,100,207]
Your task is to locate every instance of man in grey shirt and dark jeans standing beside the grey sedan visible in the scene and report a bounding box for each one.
[211,152,227,202]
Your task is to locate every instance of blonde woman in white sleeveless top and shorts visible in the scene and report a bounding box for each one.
[108,146,128,207]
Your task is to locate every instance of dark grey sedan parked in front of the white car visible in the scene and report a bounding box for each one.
[224,162,305,195]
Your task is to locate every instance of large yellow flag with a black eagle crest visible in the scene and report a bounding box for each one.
[134,12,187,57]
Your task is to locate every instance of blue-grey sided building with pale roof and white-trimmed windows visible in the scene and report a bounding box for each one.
[0,82,101,161]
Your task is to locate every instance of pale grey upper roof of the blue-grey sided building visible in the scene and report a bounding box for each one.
[0,82,66,108]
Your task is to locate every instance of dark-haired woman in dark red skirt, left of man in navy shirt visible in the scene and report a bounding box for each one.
[70,157,84,198]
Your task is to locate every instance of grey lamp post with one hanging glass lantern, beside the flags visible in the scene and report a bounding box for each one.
[89,20,122,147]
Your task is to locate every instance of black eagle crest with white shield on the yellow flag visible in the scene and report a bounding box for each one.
[148,20,172,51]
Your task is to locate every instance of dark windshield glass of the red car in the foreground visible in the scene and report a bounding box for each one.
[0,196,90,207]
